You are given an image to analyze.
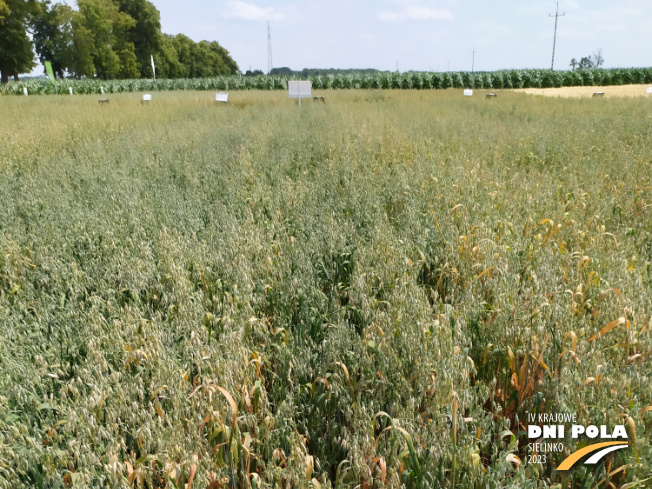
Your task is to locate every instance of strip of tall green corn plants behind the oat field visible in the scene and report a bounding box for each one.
[0,68,652,95]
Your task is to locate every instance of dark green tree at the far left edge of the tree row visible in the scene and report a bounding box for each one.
[0,0,39,83]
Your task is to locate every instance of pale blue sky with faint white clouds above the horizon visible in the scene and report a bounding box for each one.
[42,0,652,71]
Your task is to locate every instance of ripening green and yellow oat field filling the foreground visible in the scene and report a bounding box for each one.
[0,89,652,489]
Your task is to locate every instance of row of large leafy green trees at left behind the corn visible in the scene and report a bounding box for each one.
[0,0,238,83]
